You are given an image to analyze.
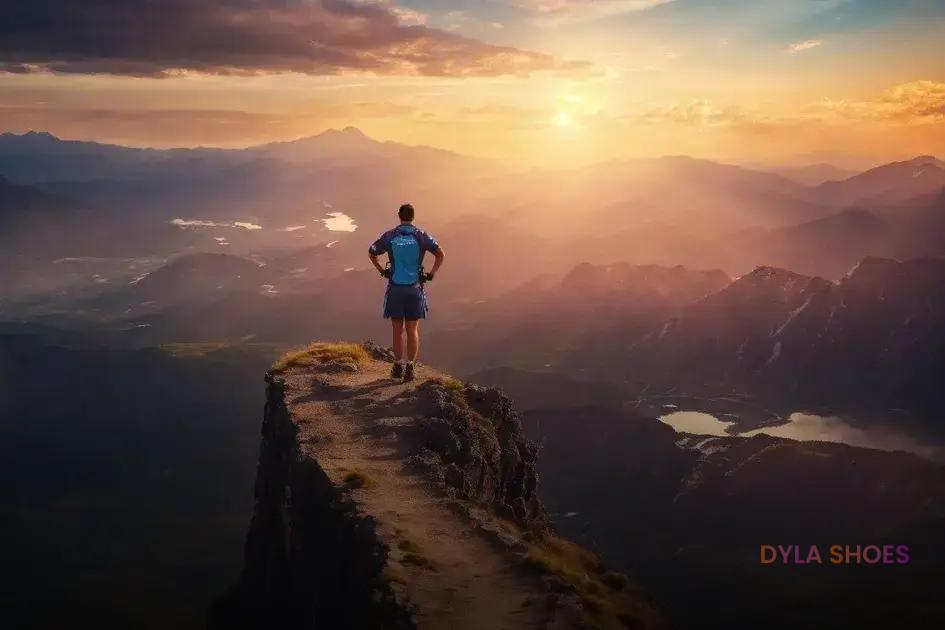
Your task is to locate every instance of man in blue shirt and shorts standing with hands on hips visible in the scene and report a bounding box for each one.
[368,203,444,381]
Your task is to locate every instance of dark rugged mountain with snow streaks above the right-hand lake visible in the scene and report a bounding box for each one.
[630,258,945,428]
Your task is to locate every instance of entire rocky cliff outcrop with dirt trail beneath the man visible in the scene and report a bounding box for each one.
[209,344,665,630]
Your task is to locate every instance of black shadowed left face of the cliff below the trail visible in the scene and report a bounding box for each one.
[209,378,412,630]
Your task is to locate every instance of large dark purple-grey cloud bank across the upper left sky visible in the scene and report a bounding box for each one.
[0,0,588,77]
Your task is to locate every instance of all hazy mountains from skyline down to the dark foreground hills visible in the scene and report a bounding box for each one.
[0,128,945,428]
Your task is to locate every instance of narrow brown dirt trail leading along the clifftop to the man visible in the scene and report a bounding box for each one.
[285,360,550,630]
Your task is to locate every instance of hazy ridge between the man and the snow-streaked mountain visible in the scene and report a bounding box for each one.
[430,263,729,372]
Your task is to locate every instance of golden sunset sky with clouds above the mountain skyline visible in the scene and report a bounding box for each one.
[0,0,945,167]
